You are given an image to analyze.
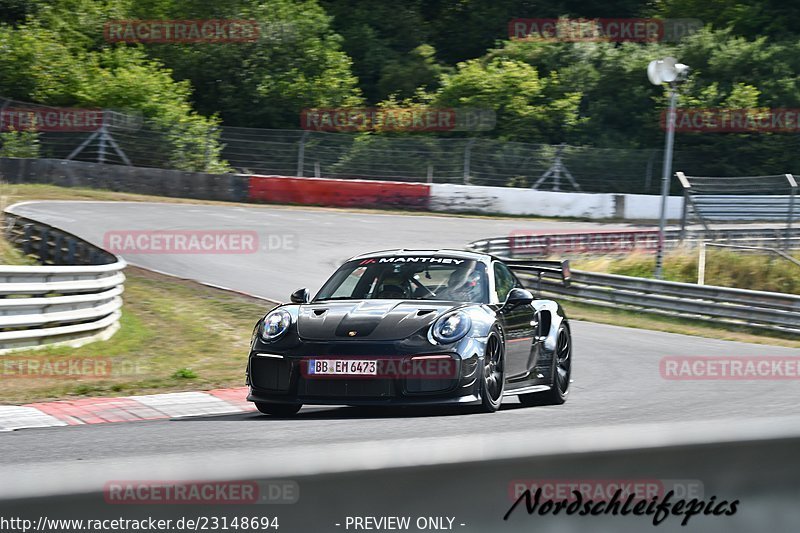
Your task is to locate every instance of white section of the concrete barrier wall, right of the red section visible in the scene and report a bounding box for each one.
[429,183,683,220]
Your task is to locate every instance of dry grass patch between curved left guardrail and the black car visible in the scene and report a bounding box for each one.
[0,267,271,404]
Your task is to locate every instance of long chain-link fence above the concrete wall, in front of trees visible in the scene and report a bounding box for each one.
[0,95,752,194]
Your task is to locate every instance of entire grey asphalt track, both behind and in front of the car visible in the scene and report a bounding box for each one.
[0,202,800,444]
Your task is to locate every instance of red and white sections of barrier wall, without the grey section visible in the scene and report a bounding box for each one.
[248,176,683,220]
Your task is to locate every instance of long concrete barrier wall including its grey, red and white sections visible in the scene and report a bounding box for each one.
[0,158,683,220]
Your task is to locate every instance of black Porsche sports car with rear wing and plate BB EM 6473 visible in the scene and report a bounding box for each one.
[247,250,572,416]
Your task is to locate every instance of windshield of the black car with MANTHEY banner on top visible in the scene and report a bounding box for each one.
[314,256,489,303]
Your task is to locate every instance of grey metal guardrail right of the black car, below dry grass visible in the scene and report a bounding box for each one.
[468,233,800,335]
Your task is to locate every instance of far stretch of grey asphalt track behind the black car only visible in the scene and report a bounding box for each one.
[4,202,644,301]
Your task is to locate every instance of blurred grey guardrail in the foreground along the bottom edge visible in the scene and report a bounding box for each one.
[0,415,800,533]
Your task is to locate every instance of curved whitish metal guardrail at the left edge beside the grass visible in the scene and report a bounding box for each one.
[0,212,126,353]
